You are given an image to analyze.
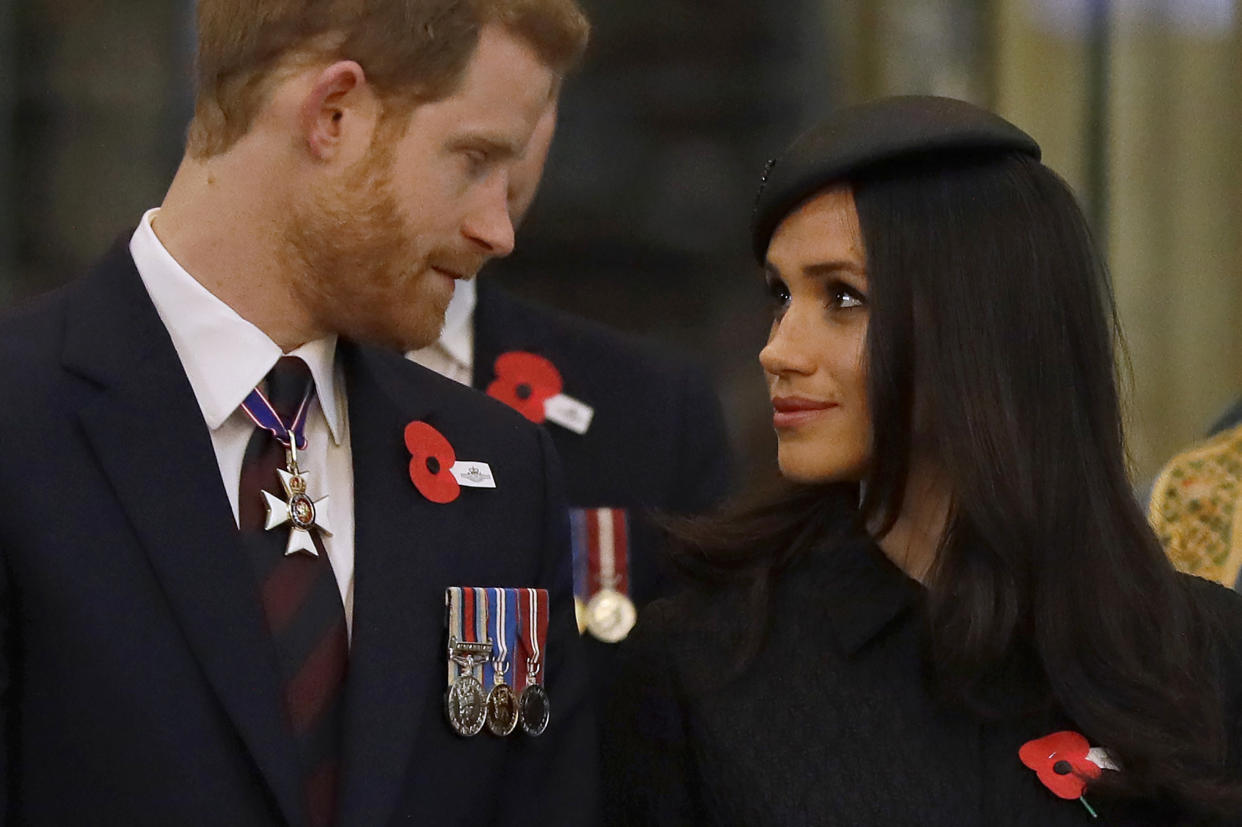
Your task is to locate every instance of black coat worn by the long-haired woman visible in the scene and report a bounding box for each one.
[605,519,1242,827]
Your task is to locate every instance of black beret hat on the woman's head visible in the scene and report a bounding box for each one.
[753,96,1040,263]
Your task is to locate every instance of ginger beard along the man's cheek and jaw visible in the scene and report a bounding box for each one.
[284,149,448,351]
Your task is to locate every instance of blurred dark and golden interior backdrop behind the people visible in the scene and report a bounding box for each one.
[0,0,1242,479]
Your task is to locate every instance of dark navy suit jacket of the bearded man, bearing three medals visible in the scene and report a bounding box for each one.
[0,245,595,827]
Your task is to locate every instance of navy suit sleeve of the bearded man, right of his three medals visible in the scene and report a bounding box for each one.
[502,428,600,827]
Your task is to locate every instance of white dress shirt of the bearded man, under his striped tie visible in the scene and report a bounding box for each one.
[129,210,354,631]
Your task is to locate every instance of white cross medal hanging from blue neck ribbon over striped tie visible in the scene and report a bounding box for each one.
[241,385,332,558]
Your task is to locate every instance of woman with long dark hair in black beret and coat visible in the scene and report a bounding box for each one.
[606,98,1242,827]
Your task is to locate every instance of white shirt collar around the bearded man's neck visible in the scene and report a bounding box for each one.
[129,210,344,445]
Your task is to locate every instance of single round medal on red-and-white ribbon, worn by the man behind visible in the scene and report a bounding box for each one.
[570,508,638,643]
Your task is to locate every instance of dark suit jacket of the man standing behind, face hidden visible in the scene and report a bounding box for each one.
[473,279,732,605]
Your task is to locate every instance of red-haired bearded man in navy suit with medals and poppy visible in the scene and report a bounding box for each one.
[0,0,595,826]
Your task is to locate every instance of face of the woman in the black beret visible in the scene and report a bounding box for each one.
[759,188,871,483]
